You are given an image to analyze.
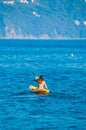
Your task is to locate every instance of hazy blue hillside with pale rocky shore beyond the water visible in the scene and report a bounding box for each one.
[0,0,86,39]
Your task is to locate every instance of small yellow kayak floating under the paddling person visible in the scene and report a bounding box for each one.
[29,85,50,94]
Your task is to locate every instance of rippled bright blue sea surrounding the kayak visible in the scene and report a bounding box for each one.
[0,40,86,130]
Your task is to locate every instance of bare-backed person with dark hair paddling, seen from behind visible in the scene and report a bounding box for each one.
[34,75,48,89]
